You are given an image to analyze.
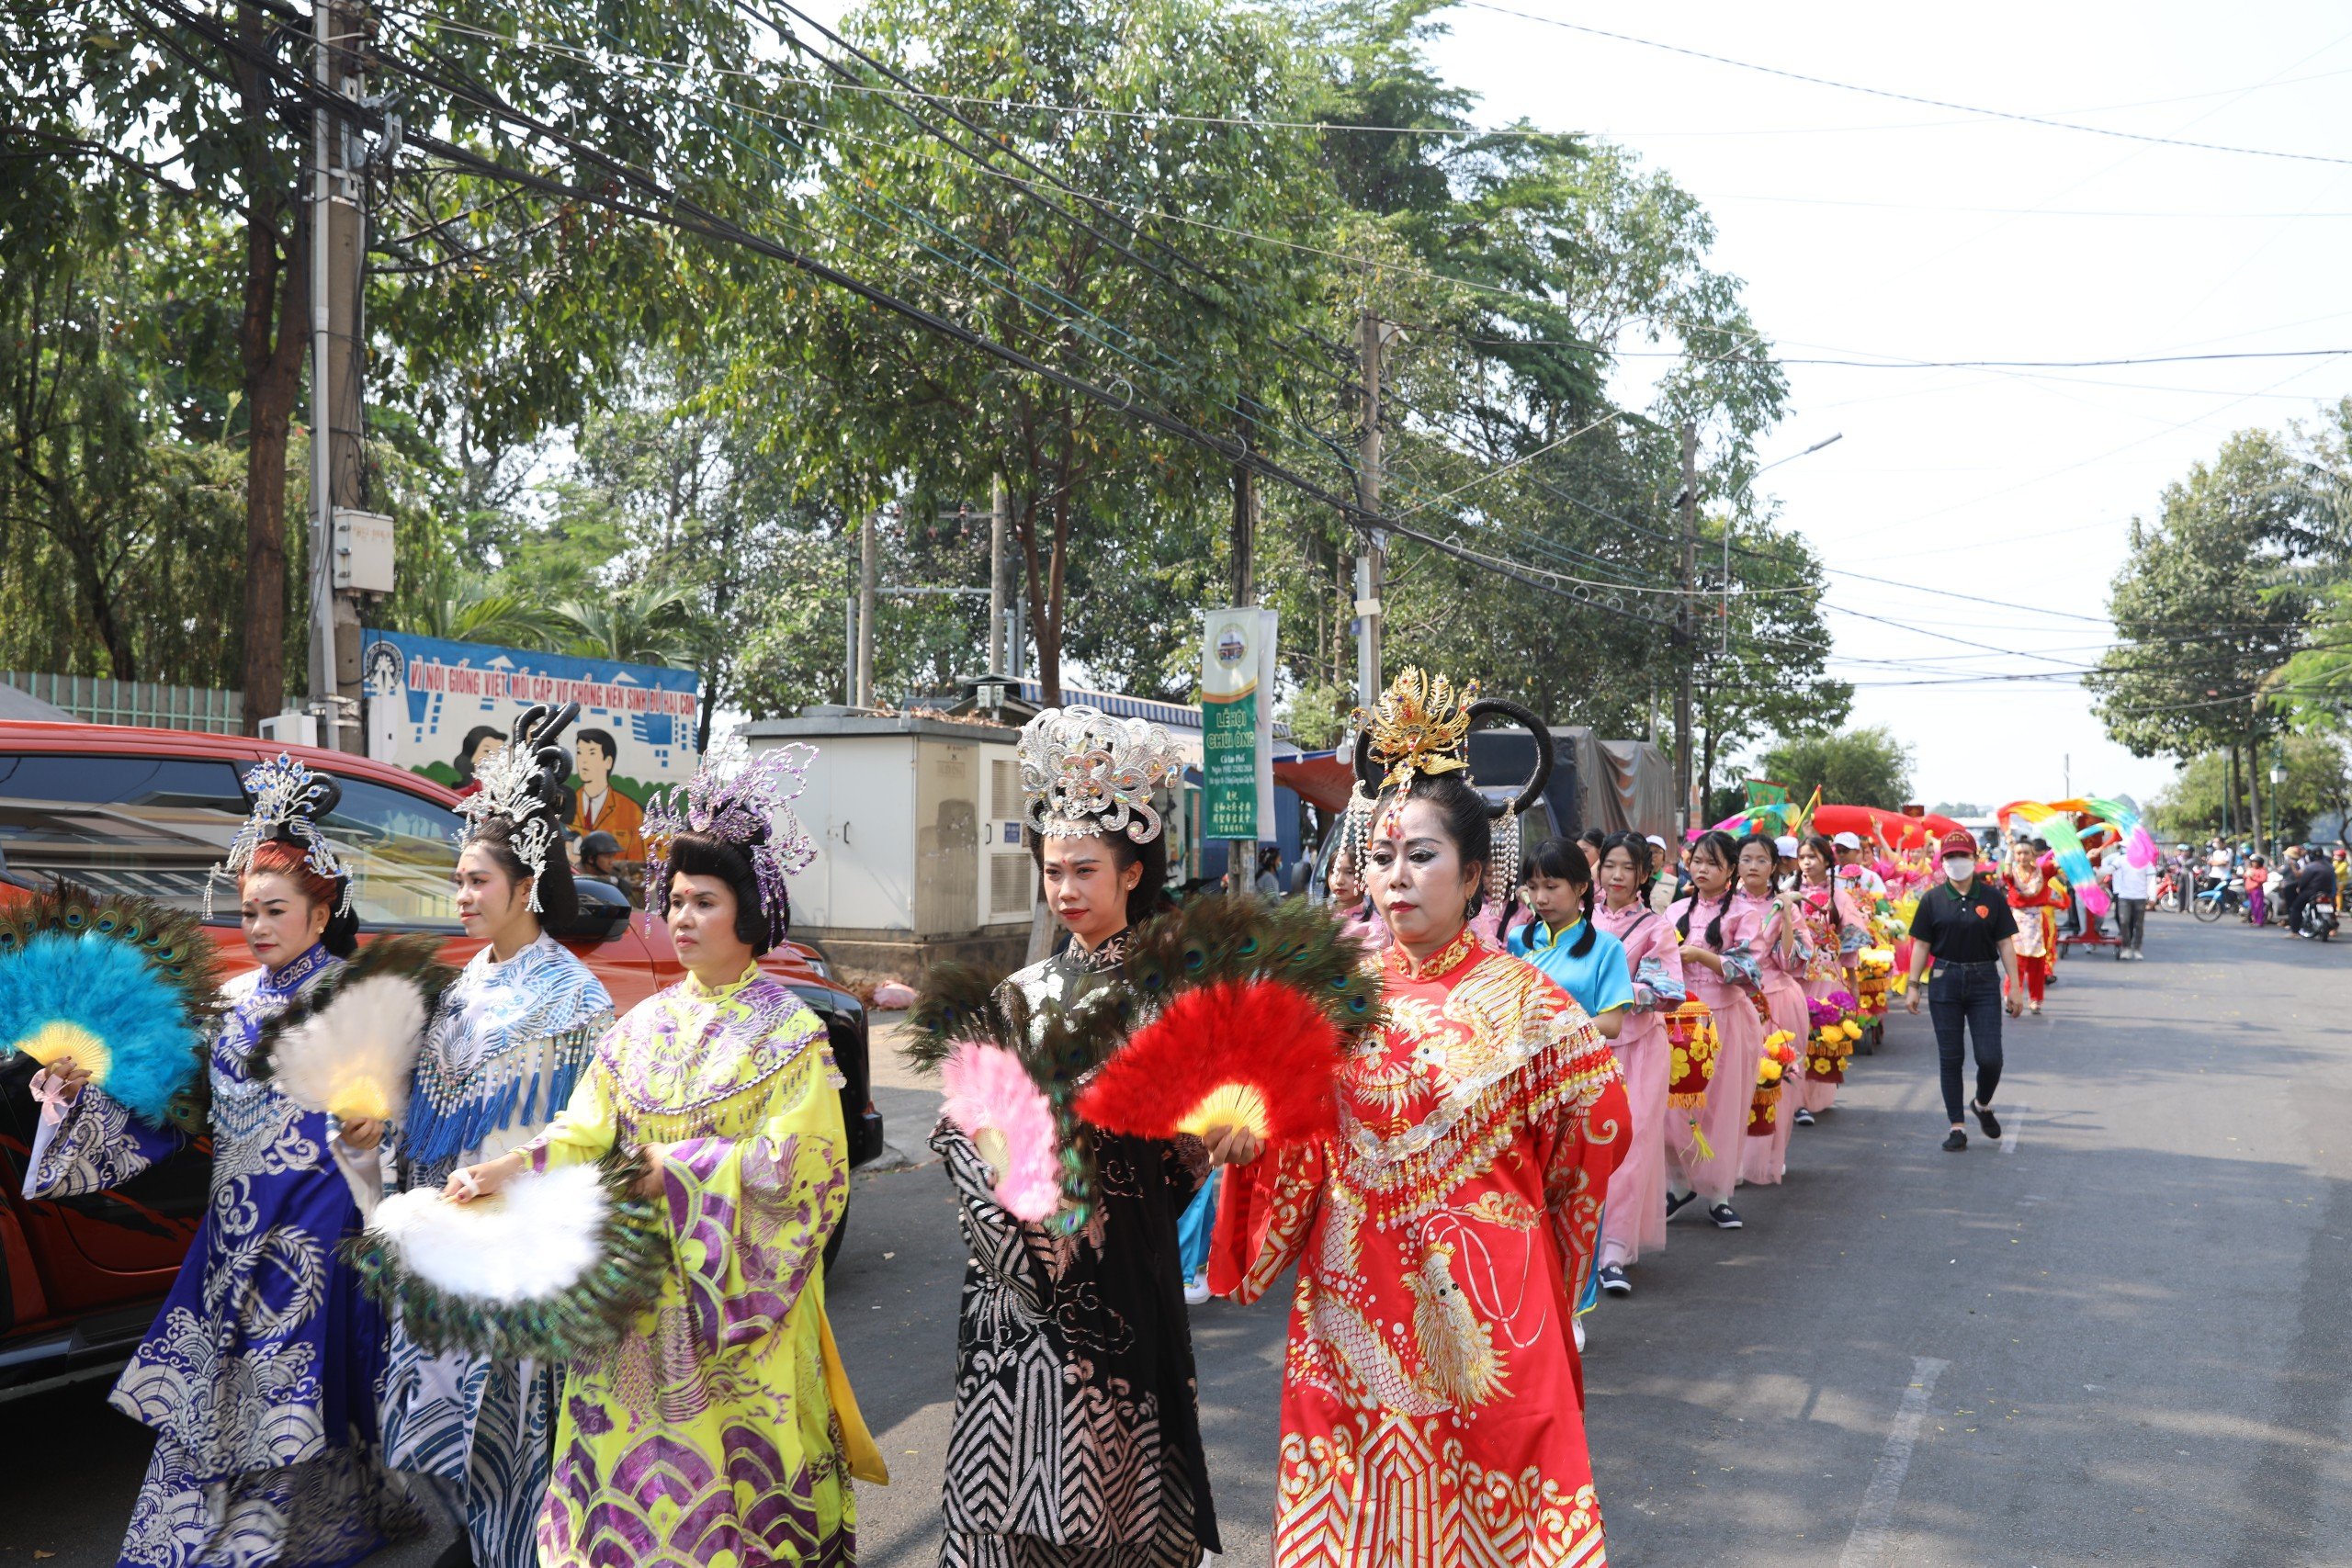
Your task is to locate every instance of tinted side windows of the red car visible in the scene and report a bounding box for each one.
[0,752,458,931]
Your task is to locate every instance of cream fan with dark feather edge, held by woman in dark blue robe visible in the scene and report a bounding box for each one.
[254,933,457,1122]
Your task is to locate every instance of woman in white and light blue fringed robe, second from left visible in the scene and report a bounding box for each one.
[383,808,612,1568]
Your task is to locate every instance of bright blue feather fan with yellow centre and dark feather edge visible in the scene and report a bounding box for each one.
[0,884,221,1134]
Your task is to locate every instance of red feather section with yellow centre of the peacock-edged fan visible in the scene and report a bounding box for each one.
[1072,980,1340,1145]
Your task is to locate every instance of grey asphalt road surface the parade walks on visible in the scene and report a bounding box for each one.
[0,917,2352,1568]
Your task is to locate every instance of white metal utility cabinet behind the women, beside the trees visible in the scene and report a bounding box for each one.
[746,707,1037,980]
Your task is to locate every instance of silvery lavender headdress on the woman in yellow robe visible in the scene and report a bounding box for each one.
[642,733,816,936]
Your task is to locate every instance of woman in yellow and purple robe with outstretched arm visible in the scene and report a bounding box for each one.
[449,752,887,1568]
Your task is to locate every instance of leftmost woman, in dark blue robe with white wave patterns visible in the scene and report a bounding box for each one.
[26,841,419,1568]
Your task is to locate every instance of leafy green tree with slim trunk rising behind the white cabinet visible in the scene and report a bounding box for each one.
[743,0,1312,696]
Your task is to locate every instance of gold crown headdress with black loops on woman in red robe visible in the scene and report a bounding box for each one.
[1340,668,1553,903]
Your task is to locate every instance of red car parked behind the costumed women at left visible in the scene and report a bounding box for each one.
[0,722,882,1394]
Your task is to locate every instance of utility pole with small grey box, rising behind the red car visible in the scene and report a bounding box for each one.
[308,0,371,752]
